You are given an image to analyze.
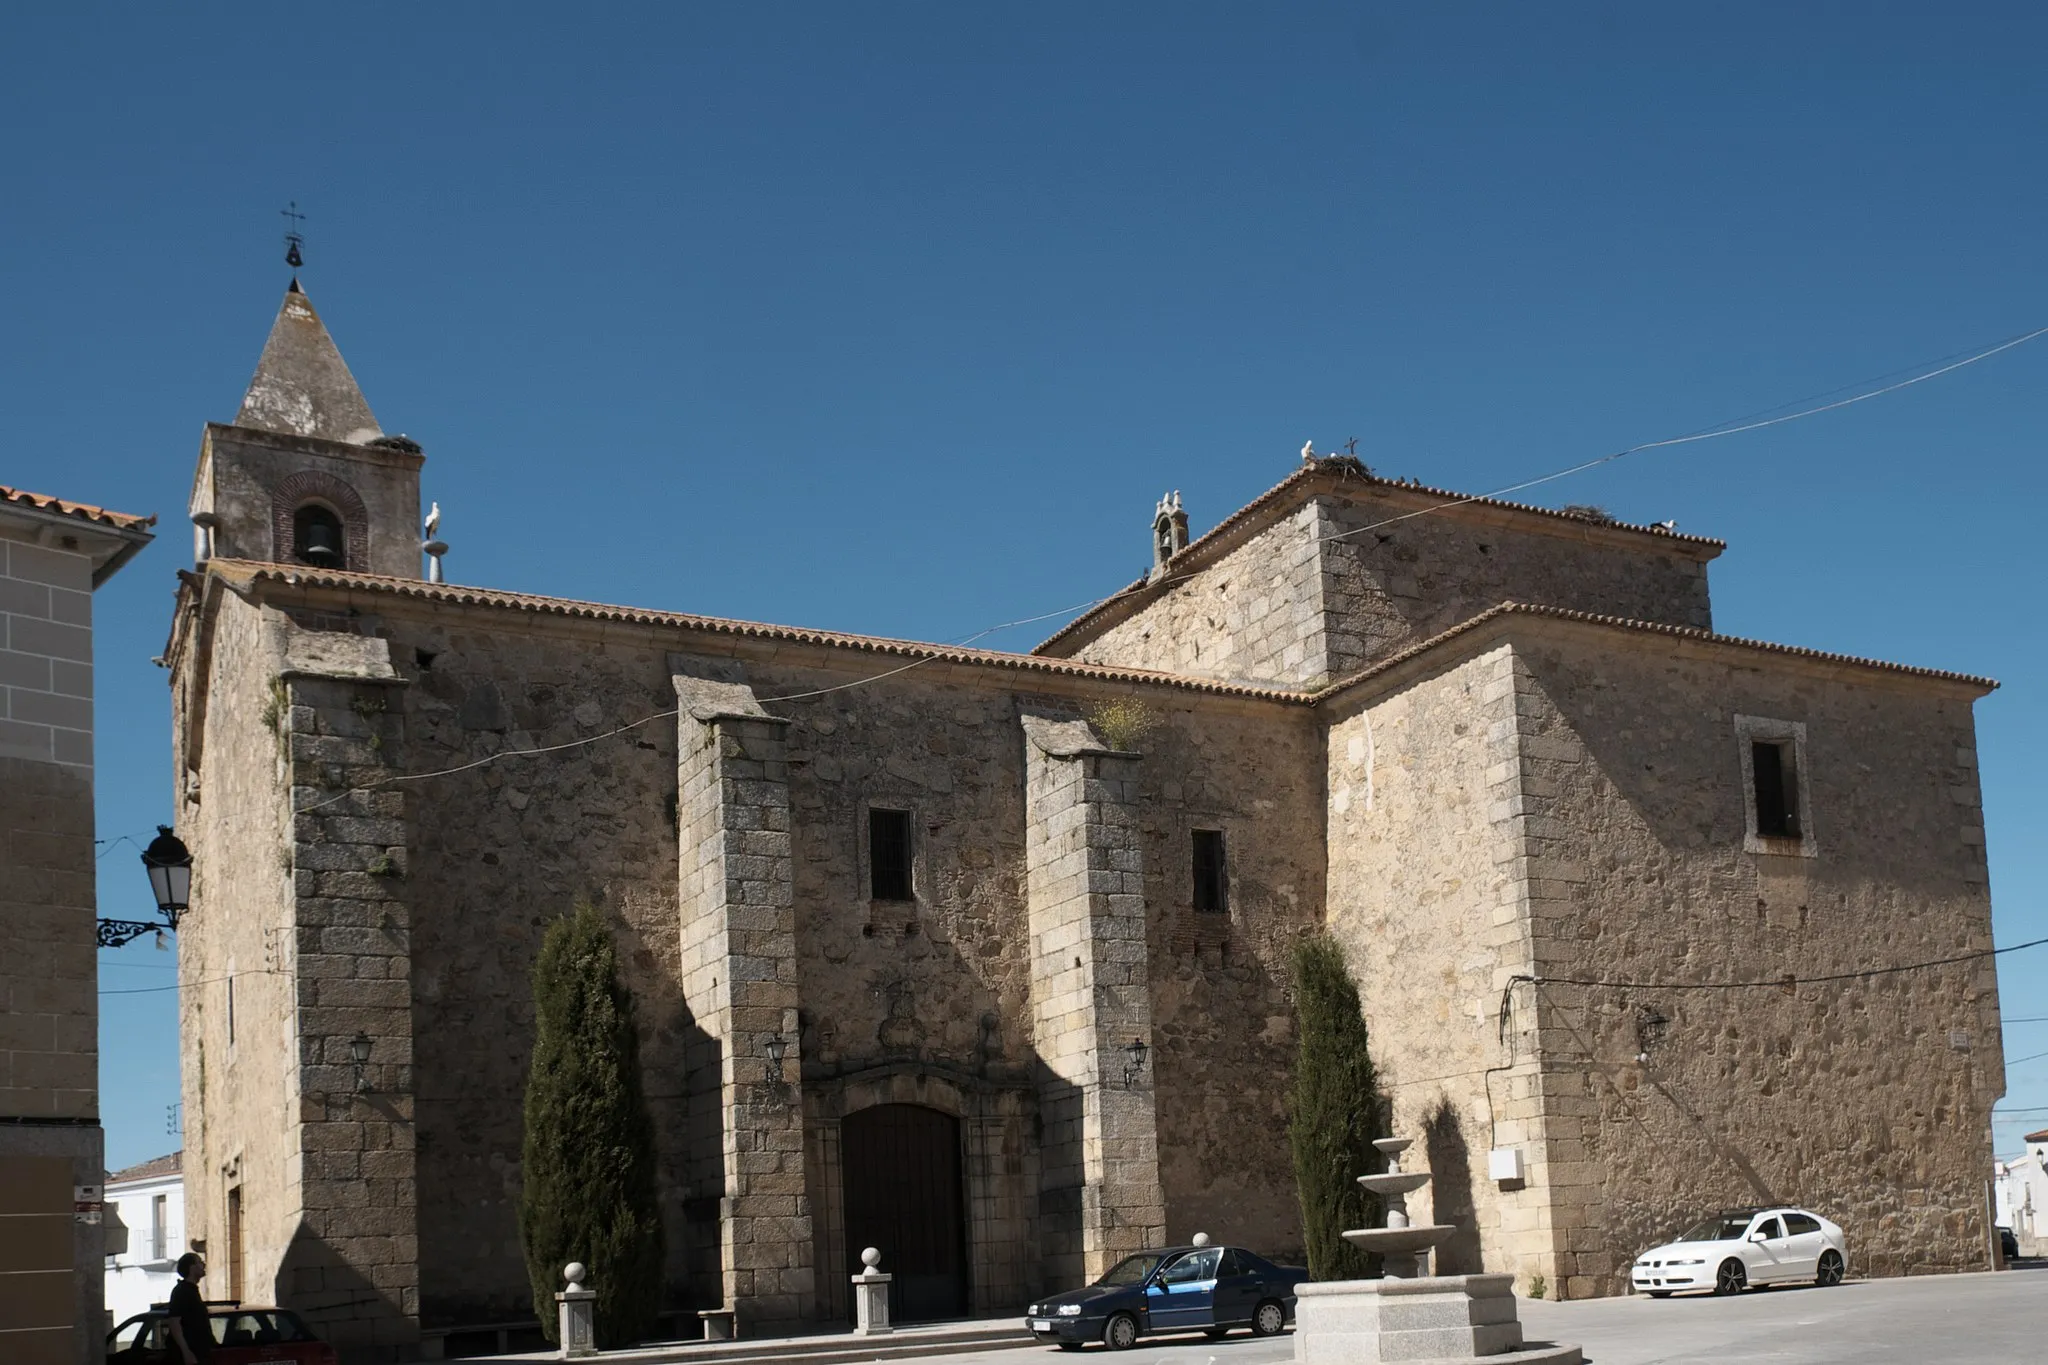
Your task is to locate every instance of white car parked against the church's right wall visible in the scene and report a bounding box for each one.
[1628,1207,1847,1300]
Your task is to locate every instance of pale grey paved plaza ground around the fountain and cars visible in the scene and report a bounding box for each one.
[905,1263,2048,1365]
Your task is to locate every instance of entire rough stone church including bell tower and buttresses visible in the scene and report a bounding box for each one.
[166,284,2003,1357]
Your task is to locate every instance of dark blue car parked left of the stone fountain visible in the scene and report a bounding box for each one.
[1024,1246,1309,1351]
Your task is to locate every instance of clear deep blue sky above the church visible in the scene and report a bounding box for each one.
[0,2,2048,1164]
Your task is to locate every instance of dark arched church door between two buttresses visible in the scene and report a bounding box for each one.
[840,1105,967,1322]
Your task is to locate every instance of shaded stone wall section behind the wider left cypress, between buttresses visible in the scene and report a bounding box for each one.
[387,614,692,1328]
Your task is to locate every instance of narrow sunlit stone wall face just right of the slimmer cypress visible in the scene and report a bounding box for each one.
[1329,647,1559,1289]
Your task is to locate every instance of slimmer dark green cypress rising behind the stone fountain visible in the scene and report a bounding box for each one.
[1288,935,1384,1279]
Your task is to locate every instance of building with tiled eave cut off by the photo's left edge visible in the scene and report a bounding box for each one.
[0,485,156,1365]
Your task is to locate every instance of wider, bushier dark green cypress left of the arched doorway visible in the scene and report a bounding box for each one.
[520,898,662,1347]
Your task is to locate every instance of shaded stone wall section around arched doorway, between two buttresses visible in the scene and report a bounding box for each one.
[774,669,1042,1318]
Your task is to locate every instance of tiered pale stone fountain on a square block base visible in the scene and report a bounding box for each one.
[1294,1138,1585,1365]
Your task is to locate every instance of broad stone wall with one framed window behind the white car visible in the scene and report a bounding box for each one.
[1516,632,2005,1297]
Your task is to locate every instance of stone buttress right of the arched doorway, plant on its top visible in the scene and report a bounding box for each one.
[1022,712,1165,1285]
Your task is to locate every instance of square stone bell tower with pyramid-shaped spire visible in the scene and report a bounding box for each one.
[190,278,426,579]
